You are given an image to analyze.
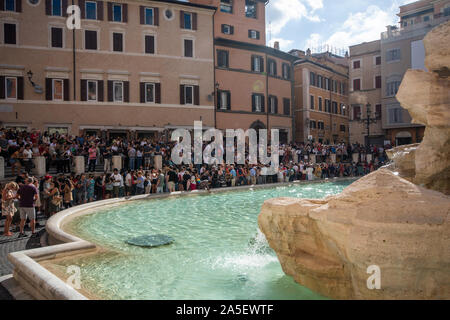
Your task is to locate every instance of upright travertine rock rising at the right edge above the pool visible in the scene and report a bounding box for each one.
[391,22,450,194]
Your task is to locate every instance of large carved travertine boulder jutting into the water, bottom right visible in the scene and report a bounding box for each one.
[258,169,450,299]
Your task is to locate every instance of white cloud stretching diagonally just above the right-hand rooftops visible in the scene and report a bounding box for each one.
[306,0,410,50]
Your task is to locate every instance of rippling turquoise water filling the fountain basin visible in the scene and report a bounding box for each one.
[67,181,352,299]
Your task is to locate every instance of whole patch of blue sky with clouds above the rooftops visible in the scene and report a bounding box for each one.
[266,0,414,51]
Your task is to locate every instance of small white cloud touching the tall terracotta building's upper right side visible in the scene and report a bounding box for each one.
[269,0,323,35]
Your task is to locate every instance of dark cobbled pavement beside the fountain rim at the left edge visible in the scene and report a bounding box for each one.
[0,214,47,300]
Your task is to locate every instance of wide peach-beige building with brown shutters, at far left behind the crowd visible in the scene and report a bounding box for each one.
[0,0,215,137]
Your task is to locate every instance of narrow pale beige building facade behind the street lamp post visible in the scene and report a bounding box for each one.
[349,40,385,145]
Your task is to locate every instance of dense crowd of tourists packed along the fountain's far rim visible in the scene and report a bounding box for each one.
[0,129,386,236]
